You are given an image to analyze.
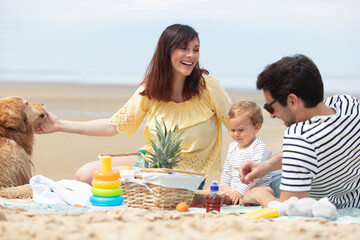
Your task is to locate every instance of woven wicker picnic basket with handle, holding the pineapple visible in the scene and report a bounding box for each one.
[102,153,203,210]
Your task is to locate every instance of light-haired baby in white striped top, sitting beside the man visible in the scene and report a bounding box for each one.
[220,101,271,205]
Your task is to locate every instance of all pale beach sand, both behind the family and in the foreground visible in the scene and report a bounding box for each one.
[0,82,360,240]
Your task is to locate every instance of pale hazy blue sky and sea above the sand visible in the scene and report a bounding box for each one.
[0,0,360,92]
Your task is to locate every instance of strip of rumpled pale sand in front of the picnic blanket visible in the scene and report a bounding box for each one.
[0,203,360,240]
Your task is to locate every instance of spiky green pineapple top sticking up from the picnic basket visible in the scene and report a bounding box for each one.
[148,117,182,168]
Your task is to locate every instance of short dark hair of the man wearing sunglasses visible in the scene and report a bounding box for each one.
[256,54,324,108]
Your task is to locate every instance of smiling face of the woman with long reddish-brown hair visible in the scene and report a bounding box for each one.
[171,38,200,77]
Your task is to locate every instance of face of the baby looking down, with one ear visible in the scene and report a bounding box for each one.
[229,114,261,149]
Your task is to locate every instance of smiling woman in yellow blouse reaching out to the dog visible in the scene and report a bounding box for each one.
[35,24,231,186]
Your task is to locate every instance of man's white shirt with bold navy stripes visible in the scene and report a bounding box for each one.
[280,95,360,208]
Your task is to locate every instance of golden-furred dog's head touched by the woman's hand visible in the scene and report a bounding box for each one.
[0,97,46,132]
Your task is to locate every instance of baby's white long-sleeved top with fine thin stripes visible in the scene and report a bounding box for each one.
[220,137,271,196]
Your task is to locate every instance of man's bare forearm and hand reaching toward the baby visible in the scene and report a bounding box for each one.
[239,153,282,184]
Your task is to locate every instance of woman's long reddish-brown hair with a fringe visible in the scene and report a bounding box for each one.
[140,24,209,102]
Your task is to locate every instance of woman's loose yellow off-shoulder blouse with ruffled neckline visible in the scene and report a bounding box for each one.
[111,75,231,176]
